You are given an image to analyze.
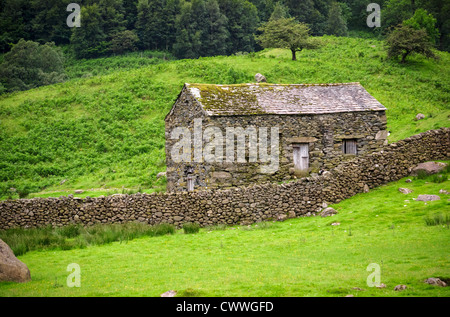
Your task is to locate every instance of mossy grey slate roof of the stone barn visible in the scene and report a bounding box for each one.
[185,83,386,116]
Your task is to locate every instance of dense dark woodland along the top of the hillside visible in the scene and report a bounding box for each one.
[0,0,450,58]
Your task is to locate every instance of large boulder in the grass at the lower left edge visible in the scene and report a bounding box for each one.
[0,239,31,283]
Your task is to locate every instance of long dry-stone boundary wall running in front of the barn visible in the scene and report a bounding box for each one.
[0,128,450,229]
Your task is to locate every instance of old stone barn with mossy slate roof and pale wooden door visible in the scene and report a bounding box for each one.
[165,83,388,191]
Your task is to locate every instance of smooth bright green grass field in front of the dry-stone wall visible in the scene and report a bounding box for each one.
[0,170,450,297]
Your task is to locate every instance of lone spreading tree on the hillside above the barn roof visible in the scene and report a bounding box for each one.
[257,18,316,61]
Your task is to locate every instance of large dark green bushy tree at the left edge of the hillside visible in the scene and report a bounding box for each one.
[0,39,66,91]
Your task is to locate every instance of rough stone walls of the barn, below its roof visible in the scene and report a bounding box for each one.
[165,84,387,191]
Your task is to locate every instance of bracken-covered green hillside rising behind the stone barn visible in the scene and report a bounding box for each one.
[0,36,450,199]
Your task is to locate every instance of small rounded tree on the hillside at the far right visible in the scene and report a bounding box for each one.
[386,24,435,63]
